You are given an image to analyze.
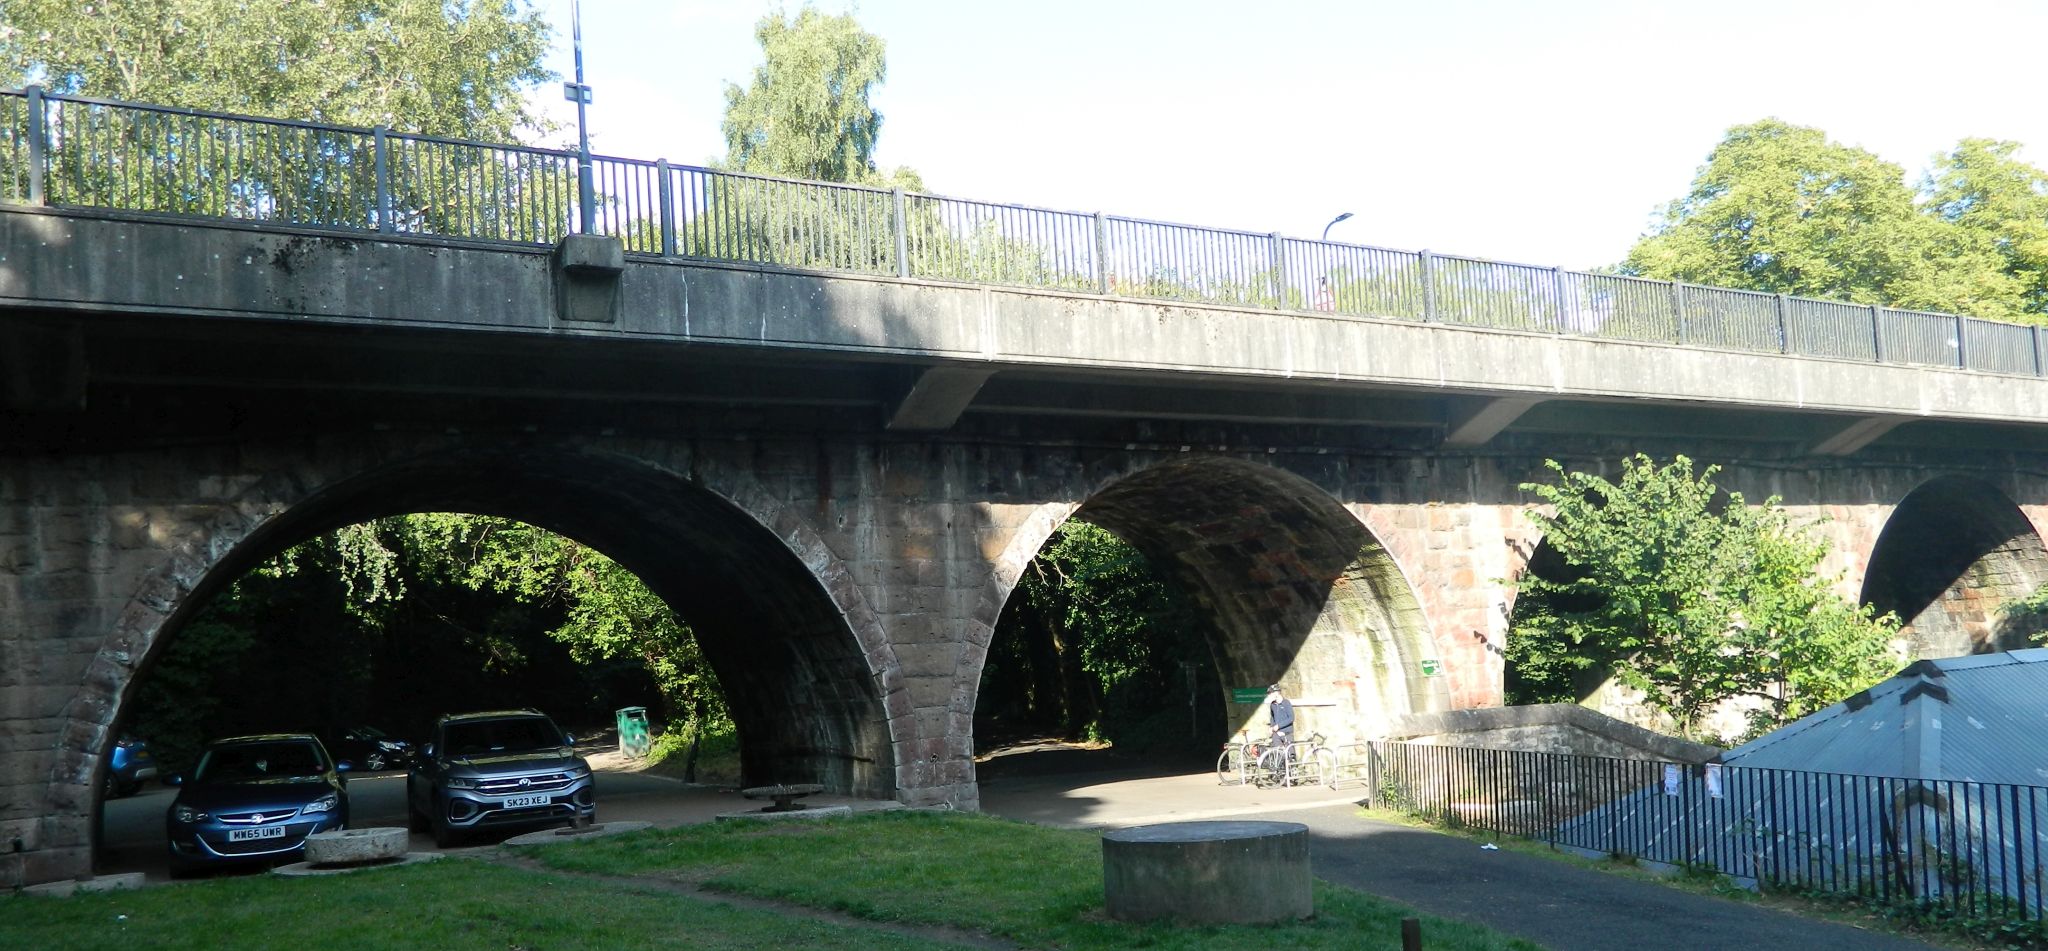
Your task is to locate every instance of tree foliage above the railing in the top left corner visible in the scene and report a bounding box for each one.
[0,0,553,141]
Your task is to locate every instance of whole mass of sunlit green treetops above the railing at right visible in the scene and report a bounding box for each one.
[1624,119,2048,320]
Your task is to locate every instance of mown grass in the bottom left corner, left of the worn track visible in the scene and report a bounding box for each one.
[0,859,956,951]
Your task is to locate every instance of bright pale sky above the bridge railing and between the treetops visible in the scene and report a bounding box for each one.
[535,0,2048,268]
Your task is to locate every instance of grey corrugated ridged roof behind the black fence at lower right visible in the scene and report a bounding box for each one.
[1722,648,2048,785]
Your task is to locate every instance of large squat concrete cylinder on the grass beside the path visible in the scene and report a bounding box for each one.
[1102,822,1315,924]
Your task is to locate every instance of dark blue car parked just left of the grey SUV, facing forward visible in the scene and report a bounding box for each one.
[164,734,348,875]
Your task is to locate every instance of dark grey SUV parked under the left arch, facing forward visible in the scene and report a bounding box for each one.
[406,709,598,849]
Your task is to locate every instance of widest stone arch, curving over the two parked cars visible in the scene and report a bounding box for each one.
[49,443,907,869]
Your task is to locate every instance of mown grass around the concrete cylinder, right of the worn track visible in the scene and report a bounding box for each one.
[535,812,1536,951]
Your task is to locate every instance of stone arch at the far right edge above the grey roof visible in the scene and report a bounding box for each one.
[1862,476,2048,660]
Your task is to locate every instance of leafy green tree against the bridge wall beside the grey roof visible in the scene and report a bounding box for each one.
[1507,455,1898,736]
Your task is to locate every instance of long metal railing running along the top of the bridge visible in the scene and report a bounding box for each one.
[0,86,2044,377]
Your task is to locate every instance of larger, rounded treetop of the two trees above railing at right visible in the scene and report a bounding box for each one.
[1622,119,2023,318]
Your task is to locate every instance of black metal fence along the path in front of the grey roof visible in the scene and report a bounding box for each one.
[1360,742,2048,920]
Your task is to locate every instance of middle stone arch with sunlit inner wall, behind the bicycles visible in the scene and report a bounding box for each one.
[958,455,1450,742]
